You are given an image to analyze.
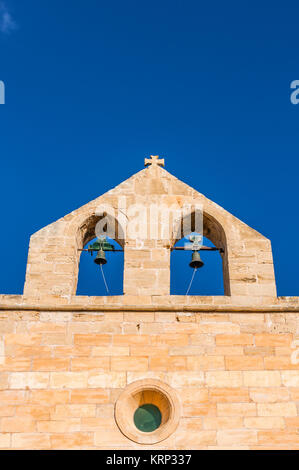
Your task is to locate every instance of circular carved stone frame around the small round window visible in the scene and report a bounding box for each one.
[114,379,181,444]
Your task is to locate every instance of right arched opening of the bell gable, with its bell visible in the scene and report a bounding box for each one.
[170,211,230,295]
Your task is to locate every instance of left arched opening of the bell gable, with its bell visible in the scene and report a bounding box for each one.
[76,213,124,296]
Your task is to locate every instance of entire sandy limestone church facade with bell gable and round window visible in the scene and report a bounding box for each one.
[0,157,299,449]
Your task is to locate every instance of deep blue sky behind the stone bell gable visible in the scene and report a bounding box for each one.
[0,0,299,295]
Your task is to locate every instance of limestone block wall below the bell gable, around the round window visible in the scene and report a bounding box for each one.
[0,296,299,449]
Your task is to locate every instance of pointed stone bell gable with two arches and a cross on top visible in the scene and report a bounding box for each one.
[24,158,276,303]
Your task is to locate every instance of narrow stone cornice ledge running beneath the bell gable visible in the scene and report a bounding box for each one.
[0,295,299,313]
